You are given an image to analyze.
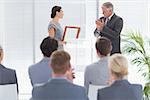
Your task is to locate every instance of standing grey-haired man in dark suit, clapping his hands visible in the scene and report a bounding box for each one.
[94,2,123,55]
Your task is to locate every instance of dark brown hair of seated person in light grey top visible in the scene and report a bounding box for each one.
[95,37,112,56]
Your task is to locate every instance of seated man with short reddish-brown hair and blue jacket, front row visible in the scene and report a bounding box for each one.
[32,50,88,100]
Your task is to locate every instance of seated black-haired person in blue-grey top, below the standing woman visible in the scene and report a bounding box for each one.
[28,37,58,85]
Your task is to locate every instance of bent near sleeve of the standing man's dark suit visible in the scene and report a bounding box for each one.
[101,18,123,39]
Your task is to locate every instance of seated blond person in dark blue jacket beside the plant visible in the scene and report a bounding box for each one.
[97,54,142,100]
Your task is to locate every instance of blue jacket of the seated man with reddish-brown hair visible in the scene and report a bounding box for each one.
[32,79,88,100]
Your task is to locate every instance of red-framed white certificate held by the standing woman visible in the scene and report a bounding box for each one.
[62,26,80,41]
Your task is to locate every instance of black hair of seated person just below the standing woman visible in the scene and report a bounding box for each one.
[40,36,58,57]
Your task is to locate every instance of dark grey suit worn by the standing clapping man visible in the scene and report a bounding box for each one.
[94,14,123,54]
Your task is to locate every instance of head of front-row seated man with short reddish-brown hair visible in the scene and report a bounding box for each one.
[51,50,71,74]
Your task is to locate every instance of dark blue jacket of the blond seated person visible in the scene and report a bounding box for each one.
[97,80,143,100]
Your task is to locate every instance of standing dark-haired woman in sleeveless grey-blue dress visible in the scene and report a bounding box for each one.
[48,6,66,50]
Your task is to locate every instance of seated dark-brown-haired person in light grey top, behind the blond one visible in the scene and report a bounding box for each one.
[84,37,112,93]
